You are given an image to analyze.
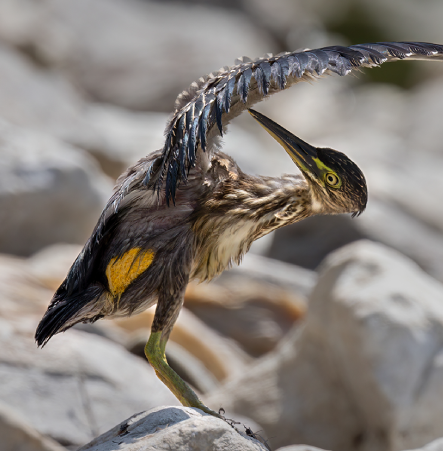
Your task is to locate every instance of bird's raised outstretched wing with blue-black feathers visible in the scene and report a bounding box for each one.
[149,42,443,201]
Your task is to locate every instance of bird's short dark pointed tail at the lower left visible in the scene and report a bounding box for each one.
[35,284,104,346]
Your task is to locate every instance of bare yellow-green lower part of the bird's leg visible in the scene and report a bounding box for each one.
[145,331,222,418]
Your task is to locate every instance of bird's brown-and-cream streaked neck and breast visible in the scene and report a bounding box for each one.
[192,175,316,280]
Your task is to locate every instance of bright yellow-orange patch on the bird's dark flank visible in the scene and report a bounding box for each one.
[106,247,155,296]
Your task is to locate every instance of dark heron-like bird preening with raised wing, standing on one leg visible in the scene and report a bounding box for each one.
[35,42,443,417]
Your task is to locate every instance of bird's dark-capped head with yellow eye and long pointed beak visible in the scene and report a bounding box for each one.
[249,109,368,216]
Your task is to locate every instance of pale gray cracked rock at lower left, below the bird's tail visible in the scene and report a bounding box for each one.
[0,328,178,446]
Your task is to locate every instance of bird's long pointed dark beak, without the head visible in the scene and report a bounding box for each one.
[248,108,321,178]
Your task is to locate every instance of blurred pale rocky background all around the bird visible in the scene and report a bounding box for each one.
[0,0,443,451]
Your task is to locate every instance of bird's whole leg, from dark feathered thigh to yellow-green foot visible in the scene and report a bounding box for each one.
[145,290,222,418]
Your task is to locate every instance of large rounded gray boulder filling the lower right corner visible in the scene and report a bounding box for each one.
[207,241,443,451]
